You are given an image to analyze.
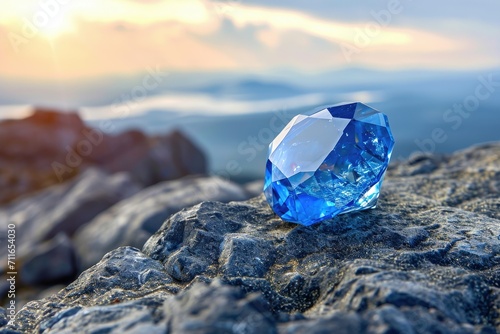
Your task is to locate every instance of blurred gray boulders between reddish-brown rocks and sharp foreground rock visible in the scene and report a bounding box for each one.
[0,175,254,306]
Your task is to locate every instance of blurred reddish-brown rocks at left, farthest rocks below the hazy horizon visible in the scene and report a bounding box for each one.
[0,109,206,204]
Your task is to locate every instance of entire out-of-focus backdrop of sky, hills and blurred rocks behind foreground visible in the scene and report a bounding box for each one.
[0,0,500,309]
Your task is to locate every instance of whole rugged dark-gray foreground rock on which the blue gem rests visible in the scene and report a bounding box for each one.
[3,144,500,334]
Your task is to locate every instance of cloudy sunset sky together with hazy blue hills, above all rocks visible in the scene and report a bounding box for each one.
[0,0,500,180]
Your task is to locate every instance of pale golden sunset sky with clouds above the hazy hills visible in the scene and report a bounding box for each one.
[0,0,500,82]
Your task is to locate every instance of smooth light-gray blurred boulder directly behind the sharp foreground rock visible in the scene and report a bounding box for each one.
[74,177,249,269]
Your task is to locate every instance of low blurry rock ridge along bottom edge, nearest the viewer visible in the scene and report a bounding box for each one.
[14,281,277,334]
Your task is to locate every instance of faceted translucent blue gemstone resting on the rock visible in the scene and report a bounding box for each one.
[264,102,394,225]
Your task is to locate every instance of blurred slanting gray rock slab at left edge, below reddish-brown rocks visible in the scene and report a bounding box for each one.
[0,168,141,266]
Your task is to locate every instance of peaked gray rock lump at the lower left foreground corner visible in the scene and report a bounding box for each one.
[5,247,179,332]
